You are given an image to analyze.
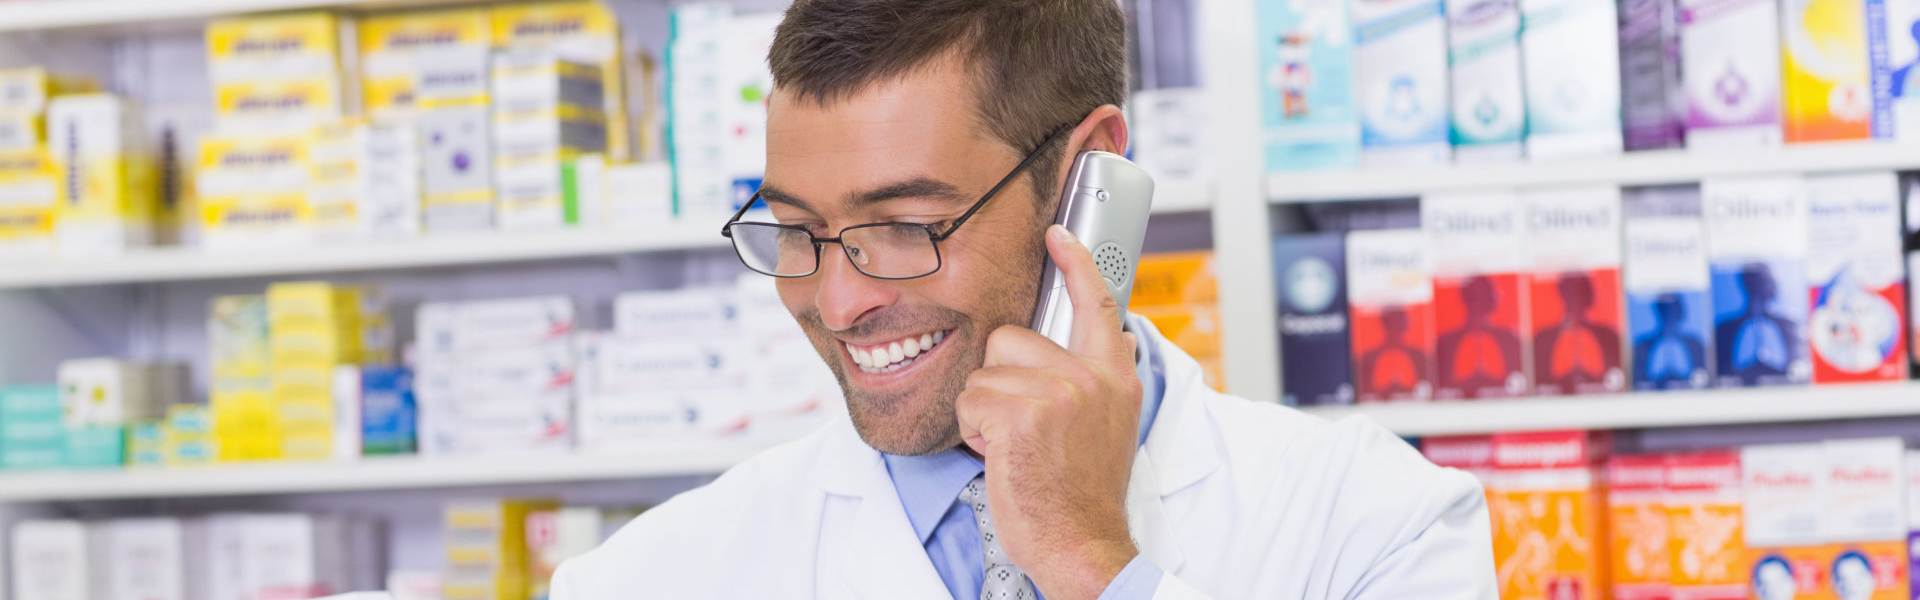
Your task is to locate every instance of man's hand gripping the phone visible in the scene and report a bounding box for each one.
[956,225,1140,600]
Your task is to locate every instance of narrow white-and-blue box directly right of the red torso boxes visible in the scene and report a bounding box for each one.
[1622,187,1715,390]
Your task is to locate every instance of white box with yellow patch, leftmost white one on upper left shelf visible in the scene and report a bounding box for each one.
[46,94,157,256]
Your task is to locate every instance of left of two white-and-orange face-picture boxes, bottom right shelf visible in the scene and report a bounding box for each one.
[1740,444,1832,600]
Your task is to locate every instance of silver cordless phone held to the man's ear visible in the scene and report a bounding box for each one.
[1033,150,1154,346]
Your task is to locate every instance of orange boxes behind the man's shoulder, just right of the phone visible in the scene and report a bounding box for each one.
[1127,250,1227,390]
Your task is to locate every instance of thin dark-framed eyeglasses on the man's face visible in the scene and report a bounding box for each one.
[720,127,1071,279]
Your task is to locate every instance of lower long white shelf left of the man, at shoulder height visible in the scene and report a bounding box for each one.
[0,440,774,504]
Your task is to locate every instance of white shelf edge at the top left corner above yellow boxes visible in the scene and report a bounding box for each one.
[0,0,460,31]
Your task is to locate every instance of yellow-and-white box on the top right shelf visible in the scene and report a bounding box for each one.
[1780,0,1880,142]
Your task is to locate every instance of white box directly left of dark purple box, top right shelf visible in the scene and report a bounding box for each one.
[1521,0,1620,160]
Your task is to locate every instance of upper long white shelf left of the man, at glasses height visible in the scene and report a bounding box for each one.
[0,217,728,288]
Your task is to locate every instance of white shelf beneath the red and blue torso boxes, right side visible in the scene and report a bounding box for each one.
[1308,383,1920,437]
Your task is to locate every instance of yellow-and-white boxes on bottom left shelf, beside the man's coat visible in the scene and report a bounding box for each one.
[440,500,557,600]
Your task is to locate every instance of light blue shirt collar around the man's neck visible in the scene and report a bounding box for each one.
[881,313,1167,544]
